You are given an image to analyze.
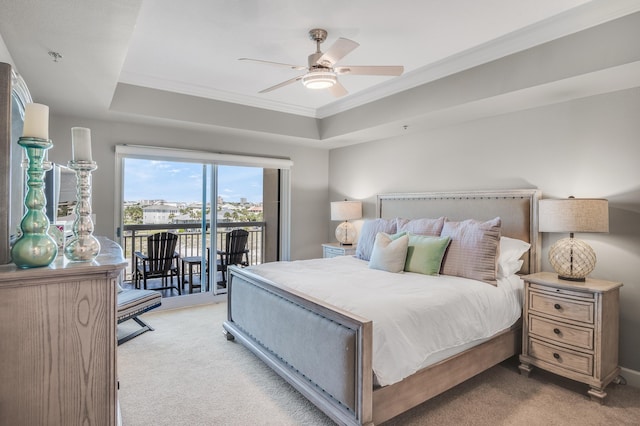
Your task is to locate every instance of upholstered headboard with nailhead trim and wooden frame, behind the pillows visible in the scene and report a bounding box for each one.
[376,189,541,274]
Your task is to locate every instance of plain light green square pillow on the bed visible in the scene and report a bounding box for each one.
[404,234,451,275]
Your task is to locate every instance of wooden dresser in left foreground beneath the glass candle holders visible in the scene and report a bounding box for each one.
[0,239,126,426]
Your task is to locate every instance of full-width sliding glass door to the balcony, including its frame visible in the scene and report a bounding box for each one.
[116,145,290,302]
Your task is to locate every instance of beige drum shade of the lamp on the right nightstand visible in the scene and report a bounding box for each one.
[538,198,609,232]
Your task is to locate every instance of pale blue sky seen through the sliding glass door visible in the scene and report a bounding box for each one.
[124,158,262,203]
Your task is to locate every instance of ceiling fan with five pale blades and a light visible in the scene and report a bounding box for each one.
[239,28,404,98]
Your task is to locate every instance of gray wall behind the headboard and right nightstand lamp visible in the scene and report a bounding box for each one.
[329,89,640,371]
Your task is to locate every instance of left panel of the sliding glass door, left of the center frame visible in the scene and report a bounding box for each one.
[120,157,211,296]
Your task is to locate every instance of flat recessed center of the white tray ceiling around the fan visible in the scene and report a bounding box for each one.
[120,0,587,116]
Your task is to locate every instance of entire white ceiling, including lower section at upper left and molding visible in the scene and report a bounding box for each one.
[0,0,640,145]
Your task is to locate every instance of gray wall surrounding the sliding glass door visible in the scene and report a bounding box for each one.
[49,113,329,259]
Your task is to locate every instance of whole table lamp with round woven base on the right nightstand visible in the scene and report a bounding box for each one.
[538,197,609,281]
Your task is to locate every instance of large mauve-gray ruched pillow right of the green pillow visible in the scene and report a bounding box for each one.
[441,217,502,285]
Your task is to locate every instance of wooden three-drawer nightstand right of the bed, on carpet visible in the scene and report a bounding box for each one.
[520,272,622,403]
